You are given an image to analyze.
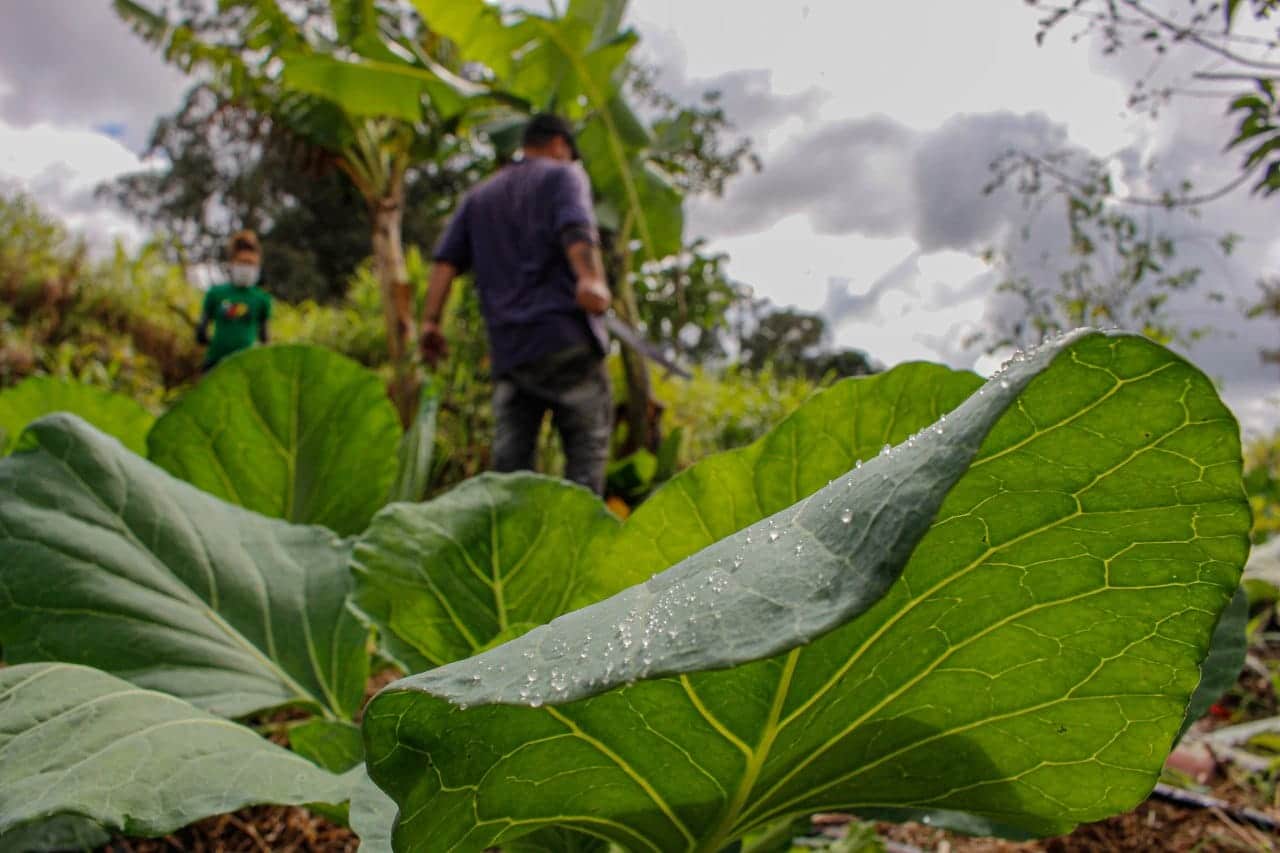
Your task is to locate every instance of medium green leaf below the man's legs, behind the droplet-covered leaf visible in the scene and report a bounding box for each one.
[351,474,617,672]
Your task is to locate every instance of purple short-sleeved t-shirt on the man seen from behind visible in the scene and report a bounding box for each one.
[433,158,608,375]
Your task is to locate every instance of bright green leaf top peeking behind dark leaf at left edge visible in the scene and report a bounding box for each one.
[0,377,155,456]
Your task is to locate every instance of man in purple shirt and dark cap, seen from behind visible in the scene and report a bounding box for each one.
[421,114,613,494]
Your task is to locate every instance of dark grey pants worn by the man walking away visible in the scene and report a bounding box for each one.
[493,347,613,494]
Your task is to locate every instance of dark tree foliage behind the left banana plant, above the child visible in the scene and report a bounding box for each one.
[100,85,488,303]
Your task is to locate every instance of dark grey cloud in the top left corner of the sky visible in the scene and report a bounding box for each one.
[0,0,187,149]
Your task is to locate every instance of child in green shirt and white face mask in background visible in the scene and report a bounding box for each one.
[196,231,271,371]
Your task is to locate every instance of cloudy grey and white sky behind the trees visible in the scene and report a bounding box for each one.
[0,0,1280,429]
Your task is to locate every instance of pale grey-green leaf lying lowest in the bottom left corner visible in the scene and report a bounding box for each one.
[0,663,348,835]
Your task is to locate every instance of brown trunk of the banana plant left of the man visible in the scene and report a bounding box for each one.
[370,181,421,429]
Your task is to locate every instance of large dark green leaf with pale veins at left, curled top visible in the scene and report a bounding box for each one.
[0,412,369,719]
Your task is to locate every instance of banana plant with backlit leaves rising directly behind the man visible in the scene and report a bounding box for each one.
[295,0,684,444]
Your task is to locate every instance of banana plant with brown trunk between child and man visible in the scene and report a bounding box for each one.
[114,0,484,427]
